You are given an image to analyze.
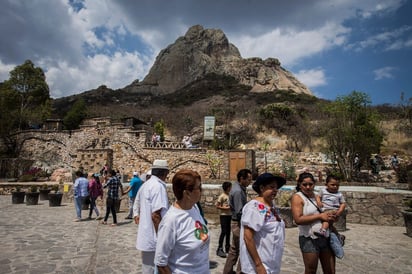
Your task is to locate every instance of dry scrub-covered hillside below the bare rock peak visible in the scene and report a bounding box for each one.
[53,74,412,158]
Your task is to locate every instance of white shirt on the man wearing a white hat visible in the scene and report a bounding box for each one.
[133,175,169,251]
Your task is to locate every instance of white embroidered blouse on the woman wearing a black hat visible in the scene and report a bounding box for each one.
[240,200,285,273]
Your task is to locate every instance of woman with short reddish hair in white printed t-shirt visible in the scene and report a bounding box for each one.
[155,170,210,274]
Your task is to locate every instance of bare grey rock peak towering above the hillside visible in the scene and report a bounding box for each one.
[125,25,312,95]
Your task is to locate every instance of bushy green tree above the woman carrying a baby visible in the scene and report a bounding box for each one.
[324,91,384,181]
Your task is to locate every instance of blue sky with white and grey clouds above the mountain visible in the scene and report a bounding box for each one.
[0,0,412,104]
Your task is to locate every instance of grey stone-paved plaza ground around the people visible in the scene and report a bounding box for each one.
[0,196,412,274]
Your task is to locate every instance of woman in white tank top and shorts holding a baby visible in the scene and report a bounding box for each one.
[292,172,335,274]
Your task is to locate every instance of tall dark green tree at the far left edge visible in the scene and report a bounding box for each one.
[4,60,51,129]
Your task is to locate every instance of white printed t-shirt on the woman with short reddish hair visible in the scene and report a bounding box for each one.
[155,205,210,274]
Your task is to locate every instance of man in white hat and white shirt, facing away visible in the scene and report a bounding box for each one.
[133,160,169,274]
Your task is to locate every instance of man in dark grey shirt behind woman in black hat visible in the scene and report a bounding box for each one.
[223,169,252,274]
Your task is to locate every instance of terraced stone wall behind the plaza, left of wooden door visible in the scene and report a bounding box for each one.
[10,118,229,179]
